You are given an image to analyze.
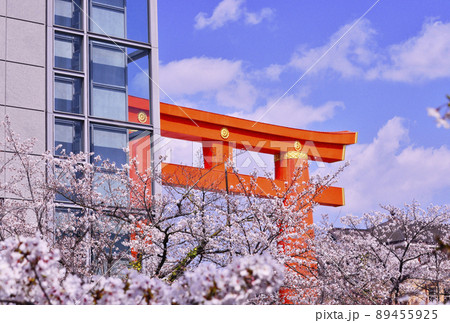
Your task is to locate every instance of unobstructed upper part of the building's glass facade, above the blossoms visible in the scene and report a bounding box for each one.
[48,0,153,195]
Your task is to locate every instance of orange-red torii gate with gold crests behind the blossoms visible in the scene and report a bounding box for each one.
[128,96,357,303]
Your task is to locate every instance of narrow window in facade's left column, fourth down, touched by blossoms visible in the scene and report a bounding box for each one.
[55,119,83,155]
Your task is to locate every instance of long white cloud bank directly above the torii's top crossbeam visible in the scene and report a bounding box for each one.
[160,57,344,123]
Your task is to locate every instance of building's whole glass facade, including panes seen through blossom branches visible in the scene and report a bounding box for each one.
[47,0,159,274]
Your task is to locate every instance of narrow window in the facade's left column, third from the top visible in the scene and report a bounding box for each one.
[55,76,83,114]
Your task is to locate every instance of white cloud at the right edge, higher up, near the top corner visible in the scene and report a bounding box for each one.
[368,21,450,82]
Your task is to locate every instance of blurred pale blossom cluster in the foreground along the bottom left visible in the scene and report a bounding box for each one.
[0,237,284,305]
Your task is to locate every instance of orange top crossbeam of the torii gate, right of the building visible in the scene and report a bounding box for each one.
[160,103,357,163]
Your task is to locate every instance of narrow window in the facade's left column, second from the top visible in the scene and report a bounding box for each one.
[55,33,81,71]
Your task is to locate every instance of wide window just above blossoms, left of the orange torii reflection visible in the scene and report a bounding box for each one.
[91,125,128,167]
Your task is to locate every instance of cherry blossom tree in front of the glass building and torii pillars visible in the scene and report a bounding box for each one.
[0,117,335,303]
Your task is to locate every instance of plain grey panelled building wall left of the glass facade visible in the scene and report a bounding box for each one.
[0,0,47,199]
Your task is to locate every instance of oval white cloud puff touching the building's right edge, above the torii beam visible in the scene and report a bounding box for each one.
[159,57,242,96]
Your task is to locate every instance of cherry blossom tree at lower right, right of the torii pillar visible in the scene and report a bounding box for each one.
[315,202,450,304]
